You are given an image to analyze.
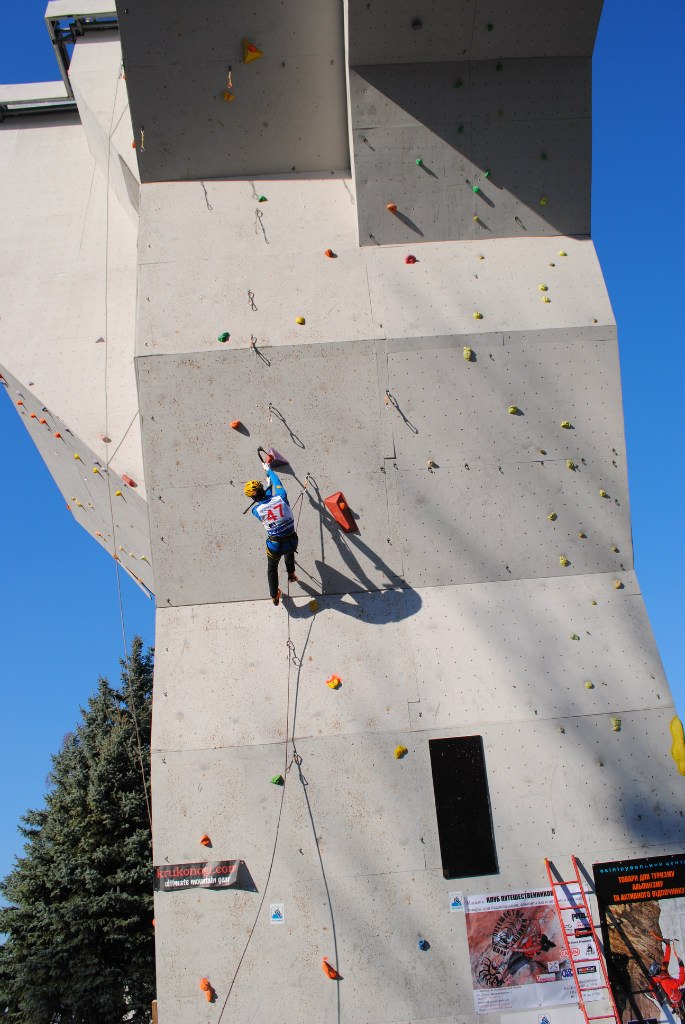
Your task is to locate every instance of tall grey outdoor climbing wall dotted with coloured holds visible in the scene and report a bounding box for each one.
[0,0,683,1024]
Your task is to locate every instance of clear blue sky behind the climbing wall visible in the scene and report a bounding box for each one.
[0,0,685,876]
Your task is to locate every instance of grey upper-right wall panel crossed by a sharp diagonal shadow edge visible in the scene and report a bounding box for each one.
[350,58,590,245]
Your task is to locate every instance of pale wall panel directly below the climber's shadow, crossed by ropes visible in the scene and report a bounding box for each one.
[153,593,422,751]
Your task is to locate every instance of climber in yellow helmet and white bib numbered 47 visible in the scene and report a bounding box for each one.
[244,457,297,604]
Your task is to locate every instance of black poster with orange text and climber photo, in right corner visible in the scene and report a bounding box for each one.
[593,854,685,1024]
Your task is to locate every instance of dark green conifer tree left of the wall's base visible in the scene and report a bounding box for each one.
[0,637,155,1024]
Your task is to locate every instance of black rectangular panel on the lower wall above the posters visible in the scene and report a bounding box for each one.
[428,736,499,879]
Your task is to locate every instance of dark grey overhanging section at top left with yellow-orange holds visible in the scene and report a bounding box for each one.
[118,0,349,182]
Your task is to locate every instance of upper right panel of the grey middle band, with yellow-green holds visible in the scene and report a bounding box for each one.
[385,336,625,468]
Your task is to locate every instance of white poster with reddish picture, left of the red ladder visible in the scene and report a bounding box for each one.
[465,889,577,1014]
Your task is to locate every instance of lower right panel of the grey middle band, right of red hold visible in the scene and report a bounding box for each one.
[397,459,633,587]
